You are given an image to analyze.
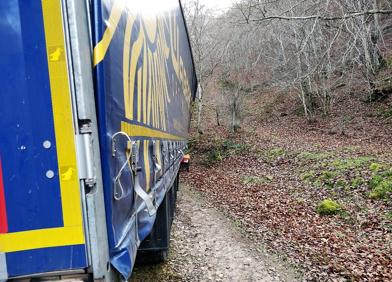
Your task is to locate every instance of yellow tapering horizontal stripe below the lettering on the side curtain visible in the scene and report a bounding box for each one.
[121,121,186,140]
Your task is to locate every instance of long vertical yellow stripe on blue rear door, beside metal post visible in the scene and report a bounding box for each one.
[42,0,82,226]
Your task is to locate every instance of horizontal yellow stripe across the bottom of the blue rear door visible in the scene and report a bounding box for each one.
[0,227,84,253]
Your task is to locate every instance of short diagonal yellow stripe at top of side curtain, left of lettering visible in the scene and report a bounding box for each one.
[93,0,125,66]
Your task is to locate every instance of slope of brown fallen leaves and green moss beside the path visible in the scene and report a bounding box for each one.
[183,94,392,281]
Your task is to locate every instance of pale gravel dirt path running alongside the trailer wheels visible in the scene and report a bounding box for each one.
[130,187,298,281]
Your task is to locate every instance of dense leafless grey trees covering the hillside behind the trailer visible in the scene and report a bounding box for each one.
[186,0,392,129]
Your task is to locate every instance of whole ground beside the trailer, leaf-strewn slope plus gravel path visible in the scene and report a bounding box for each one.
[132,91,392,281]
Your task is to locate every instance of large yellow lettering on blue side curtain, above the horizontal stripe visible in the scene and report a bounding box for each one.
[123,12,191,131]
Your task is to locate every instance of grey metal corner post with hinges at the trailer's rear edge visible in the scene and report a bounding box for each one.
[63,0,112,282]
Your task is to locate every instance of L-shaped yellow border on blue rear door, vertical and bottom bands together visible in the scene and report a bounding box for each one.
[0,0,85,253]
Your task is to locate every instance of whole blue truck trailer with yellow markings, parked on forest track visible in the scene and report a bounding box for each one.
[0,0,197,281]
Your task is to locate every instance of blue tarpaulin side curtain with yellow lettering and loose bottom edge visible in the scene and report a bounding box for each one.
[93,0,196,277]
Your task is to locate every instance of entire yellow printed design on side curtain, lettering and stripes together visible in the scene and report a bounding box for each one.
[94,0,192,196]
